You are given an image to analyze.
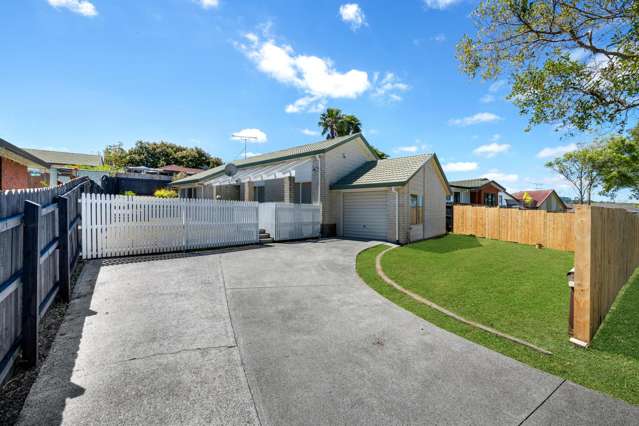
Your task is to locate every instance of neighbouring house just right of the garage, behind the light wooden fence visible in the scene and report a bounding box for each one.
[448,178,512,207]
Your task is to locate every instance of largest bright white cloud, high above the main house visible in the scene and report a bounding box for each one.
[236,33,371,112]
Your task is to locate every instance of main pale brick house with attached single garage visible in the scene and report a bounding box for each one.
[172,134,450,243]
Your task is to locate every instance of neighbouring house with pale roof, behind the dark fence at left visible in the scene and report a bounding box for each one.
[25,148,102,185]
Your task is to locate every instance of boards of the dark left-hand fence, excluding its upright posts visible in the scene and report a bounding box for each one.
[0,178,93,383]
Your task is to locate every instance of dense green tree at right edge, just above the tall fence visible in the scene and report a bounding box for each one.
[597,128,639,199]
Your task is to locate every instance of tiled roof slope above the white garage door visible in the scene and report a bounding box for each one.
[331,154,433,189]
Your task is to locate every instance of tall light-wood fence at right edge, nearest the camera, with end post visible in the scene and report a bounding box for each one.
[573,206,639,343]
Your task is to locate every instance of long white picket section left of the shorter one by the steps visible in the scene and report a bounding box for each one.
[81,194,259,259]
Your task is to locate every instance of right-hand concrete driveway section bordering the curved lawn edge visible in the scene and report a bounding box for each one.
[221,240,639,425]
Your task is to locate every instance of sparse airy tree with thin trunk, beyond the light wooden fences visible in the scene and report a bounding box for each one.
[546,146,601,204]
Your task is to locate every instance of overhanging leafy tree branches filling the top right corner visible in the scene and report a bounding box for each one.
[457,0,639,130]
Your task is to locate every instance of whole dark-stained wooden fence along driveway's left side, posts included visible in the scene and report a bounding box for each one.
[0,178,91,383]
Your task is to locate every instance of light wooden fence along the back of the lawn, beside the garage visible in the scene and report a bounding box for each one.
[453,205,575,251]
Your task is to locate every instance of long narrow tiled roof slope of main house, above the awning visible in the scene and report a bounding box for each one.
[173,133,368,185]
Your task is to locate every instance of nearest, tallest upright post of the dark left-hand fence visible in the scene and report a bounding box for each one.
[22,201,42,367]
